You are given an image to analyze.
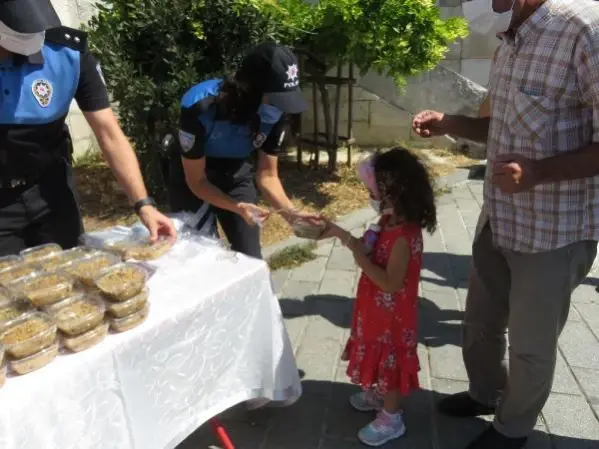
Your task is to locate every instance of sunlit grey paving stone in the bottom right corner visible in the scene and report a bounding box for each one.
[543,394,599,442]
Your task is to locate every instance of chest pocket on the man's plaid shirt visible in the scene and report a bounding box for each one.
[509,89,553,142]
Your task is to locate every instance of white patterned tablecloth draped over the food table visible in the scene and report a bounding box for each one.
[0,245,301,449]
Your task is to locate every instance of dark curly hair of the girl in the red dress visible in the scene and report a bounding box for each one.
[373,147,437,233]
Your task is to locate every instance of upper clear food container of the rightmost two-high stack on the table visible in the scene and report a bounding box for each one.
[95,263,148,301]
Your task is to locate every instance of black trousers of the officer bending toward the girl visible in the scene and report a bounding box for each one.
[169,168,262,259]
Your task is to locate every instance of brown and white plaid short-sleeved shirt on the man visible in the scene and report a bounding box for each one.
[486,0,599,252]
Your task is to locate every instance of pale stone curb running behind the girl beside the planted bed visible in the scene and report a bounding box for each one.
[262,168,470,260]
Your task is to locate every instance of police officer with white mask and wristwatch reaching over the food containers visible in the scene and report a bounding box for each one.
[0,0,175,256]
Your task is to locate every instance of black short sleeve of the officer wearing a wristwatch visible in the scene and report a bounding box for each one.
[75,51,110,112]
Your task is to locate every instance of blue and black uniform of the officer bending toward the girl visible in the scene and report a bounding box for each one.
[169,79,284,257]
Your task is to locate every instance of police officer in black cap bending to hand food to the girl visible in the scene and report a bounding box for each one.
[169,42,316,258]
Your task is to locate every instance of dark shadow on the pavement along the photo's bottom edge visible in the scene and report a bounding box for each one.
[177,380,597,449]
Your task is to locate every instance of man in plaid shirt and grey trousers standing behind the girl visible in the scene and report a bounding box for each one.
[413,0,599,449]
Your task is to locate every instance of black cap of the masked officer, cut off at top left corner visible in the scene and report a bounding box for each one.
[0,0,61,34]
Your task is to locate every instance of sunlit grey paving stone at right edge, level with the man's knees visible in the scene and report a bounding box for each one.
[560,322,599,370]
